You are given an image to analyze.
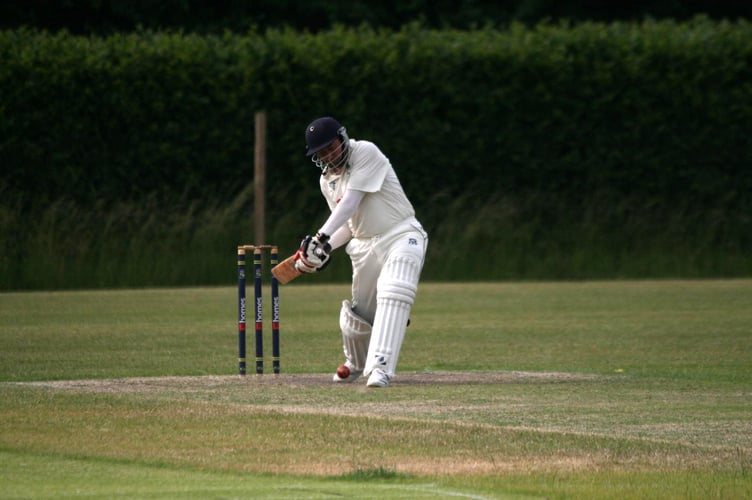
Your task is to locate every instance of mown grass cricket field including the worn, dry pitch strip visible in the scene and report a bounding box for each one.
[0,277,752,499]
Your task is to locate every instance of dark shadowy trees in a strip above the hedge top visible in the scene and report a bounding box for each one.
[0,0,752,35]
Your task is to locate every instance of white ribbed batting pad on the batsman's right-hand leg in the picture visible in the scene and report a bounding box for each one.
[364,255,422,377]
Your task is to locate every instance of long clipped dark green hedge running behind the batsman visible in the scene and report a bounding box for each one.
[0,18,752,287]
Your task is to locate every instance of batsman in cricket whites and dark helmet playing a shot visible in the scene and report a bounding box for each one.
[295,117,428,387]
